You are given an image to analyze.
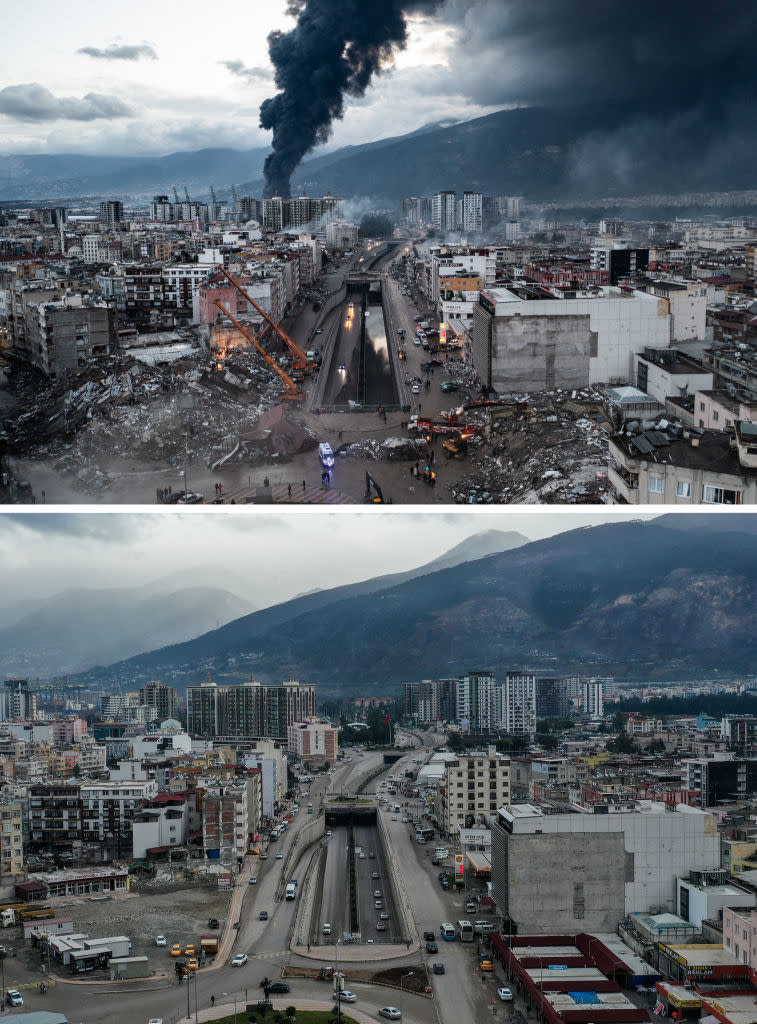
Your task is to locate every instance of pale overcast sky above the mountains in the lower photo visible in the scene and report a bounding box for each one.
[0,508,645,609]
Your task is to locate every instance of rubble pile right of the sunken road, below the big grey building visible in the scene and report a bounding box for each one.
[452,389,612,505]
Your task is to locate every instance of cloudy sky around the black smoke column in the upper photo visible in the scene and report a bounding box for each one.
[0,0,757,156]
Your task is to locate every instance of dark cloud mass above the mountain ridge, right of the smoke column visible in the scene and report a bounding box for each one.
[440,0,757,115]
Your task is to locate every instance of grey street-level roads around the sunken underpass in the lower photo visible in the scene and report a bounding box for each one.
[39,737,509,1024]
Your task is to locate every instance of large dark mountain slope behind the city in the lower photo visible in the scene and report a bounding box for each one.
[72,515,757,694]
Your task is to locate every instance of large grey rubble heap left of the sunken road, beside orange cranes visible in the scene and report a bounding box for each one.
[3,352,292,493]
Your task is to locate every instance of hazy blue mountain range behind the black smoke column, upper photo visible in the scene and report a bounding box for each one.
[0,104,753,202]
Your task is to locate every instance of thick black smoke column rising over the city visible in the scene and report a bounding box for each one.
[260,0,441,198]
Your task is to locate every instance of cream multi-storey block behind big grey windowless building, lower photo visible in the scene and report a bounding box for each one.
[437,746,510,836]
